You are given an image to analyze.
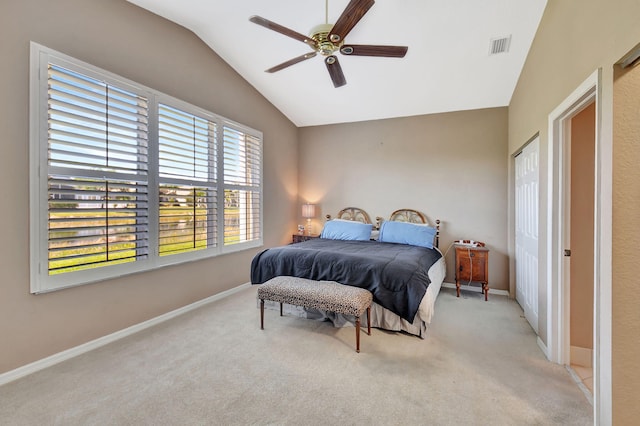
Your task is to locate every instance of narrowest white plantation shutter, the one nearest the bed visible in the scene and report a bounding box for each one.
[223,125,262,245]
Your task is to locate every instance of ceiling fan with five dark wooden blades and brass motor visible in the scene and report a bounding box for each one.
[249,0,408,87]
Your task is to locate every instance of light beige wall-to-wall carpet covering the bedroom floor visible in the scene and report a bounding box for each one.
[0,286,593,425]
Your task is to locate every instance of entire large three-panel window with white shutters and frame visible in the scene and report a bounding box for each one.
[30,43,262,293]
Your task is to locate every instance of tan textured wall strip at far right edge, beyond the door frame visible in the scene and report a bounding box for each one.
[613,61,640,424]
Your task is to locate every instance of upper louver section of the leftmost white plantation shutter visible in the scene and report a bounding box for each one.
[48,65,148,175]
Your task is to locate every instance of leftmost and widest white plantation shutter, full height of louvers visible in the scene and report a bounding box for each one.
[47,65,149,275]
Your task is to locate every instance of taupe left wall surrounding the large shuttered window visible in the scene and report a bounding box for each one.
[0,0,298,373]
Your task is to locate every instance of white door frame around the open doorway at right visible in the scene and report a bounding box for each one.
[546,69,612,419]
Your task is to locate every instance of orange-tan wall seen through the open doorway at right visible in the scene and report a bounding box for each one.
[569,104,596,349]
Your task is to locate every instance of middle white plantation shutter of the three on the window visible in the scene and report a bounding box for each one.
[158,104,217,256]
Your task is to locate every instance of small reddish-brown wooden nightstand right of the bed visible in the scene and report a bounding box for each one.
[455,243,489,301]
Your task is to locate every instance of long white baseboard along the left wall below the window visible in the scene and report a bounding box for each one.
[0,283,251,386]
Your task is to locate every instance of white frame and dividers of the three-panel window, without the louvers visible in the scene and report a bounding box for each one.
[29,42,264,294]
